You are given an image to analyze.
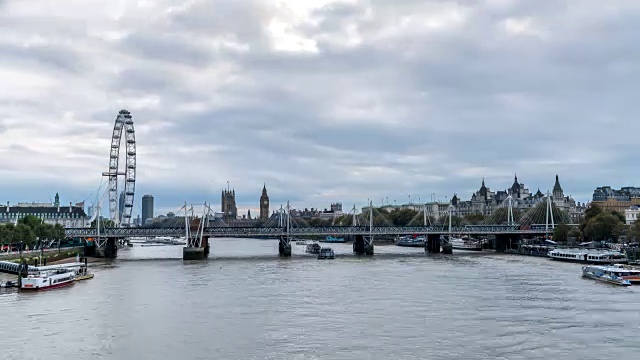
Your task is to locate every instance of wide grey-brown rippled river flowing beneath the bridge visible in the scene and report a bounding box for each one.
[0,239,640,360]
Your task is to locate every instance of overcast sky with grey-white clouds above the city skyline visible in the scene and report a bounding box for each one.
[0,0,640,217]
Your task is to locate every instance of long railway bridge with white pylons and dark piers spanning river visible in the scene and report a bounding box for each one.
[65,195,568,260]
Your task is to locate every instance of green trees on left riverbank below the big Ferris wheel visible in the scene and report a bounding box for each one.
[0,215,65,246]
